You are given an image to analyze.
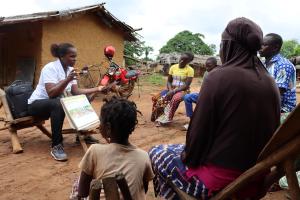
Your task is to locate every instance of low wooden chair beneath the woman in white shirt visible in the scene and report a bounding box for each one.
[0,89,97,153]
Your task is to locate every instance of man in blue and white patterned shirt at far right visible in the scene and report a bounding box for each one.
[259,33,296,113]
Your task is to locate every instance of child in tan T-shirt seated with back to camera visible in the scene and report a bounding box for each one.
[72,97,154,200]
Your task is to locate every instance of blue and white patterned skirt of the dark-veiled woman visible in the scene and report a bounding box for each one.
[149,144,209,200]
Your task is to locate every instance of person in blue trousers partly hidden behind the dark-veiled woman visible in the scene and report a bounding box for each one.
[183,57,217,130]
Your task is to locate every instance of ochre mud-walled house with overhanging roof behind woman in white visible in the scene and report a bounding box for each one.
[0,4,137,87]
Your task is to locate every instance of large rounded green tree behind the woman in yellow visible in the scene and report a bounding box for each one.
[159,31,214,55]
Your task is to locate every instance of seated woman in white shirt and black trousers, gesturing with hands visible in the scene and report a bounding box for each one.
[28,43,106,161]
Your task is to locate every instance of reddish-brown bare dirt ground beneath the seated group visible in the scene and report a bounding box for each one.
[0,76,296,200]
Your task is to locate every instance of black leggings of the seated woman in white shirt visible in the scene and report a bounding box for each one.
[28,99,65,147]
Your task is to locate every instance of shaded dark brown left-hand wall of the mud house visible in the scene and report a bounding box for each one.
[0,22,42,86]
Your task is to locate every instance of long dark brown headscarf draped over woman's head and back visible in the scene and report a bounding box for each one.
[183,18,280,171]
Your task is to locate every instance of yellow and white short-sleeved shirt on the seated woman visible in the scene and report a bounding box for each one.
[169,64,194,87]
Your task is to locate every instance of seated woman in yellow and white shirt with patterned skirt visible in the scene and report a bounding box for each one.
[152,53,194,126]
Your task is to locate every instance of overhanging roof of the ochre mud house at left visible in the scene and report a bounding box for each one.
[0,3,137,41]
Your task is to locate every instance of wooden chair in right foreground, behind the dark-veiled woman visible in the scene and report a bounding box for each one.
[167,104,300,200]
